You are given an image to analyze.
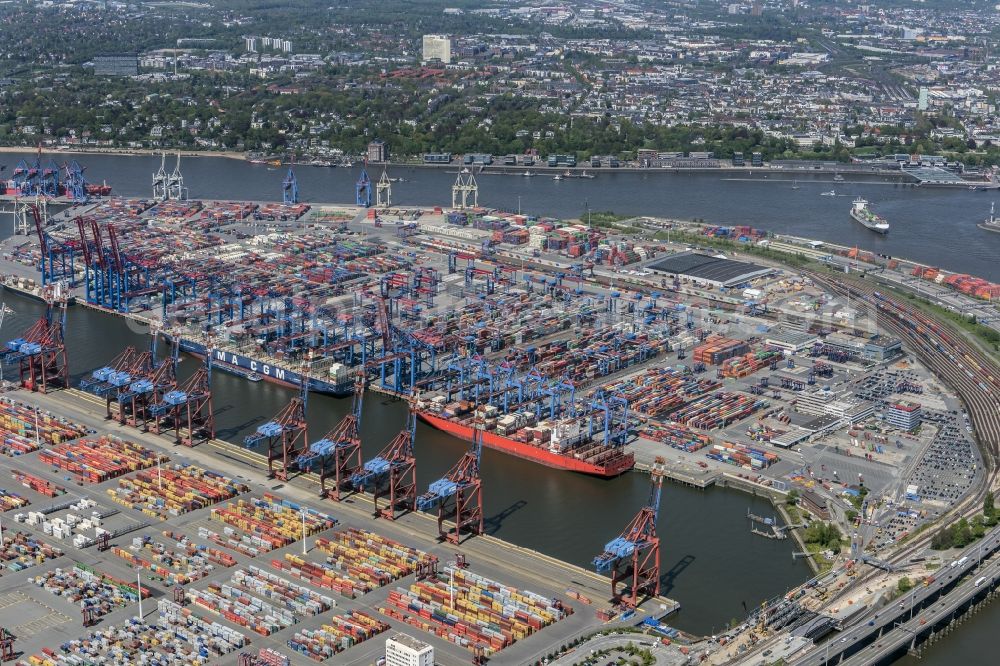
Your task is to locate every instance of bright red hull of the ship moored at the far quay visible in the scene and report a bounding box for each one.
[417,408,635,479]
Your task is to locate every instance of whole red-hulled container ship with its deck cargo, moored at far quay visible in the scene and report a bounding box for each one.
[417,400,635,478]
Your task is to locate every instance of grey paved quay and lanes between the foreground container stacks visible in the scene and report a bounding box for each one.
[0,389,679,664]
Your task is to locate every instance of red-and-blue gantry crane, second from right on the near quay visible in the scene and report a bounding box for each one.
[417,423,483,545]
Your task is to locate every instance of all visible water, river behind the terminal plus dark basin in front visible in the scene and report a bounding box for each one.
[0,149,1000,648]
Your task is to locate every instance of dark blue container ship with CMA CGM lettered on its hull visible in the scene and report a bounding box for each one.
[172,337,354,397]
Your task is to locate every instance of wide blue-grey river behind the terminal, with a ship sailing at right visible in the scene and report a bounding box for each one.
[0,153,1000,282]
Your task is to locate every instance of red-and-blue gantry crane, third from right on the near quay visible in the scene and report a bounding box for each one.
[351,401,417,520]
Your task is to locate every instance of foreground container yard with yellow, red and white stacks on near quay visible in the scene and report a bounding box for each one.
[0,374,672,664]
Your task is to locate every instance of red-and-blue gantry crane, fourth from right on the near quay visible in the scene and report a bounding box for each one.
[295,372,365,502]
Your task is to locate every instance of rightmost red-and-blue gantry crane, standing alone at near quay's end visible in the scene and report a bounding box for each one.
[594,457,666,608]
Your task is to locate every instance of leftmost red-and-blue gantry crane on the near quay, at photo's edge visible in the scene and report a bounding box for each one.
[0,283,69,393]
